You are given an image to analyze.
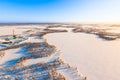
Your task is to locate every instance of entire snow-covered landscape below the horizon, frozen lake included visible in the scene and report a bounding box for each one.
[0,24,120,80]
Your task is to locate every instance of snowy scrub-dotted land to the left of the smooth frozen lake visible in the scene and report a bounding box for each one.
[0,25,85,80]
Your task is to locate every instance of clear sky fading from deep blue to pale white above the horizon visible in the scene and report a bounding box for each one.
[0,0,120,23]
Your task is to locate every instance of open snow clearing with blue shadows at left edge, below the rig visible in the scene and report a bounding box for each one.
[0,46,29,67]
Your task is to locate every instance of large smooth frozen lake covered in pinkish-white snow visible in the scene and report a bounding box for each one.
[44,32,120,80]
